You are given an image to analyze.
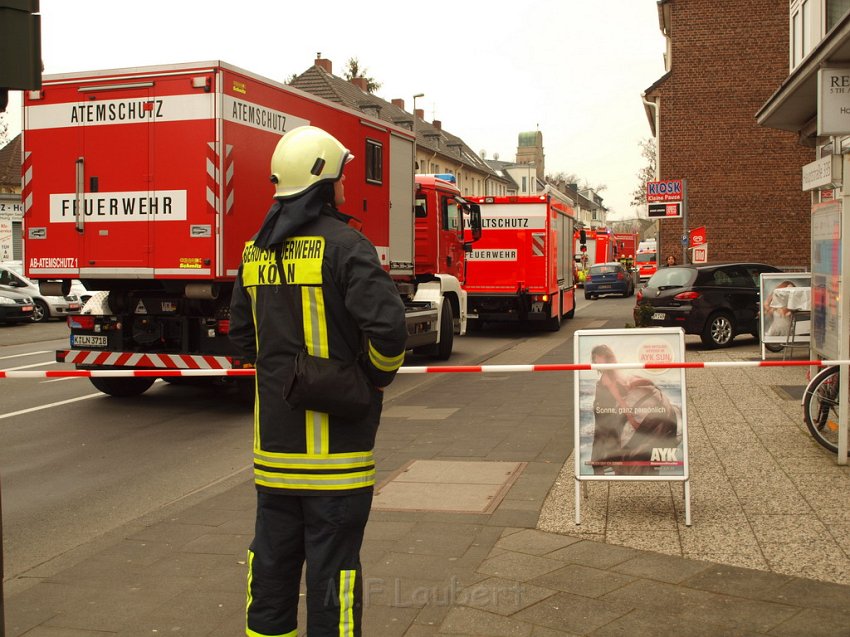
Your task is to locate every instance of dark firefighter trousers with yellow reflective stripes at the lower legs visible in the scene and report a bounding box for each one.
[246,489,372,637]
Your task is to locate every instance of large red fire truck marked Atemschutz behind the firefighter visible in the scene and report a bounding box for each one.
[23,61,480,396]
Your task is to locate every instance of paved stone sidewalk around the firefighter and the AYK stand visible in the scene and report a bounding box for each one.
[5,328,850,637]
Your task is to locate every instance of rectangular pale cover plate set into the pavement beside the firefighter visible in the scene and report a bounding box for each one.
[372,460,526,513]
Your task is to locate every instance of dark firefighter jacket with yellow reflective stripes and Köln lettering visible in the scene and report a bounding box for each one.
[230,207,407,495]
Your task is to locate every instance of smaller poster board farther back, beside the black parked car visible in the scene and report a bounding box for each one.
[759,272,812,350]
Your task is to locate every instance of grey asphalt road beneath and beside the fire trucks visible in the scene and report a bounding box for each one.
[0,293,634,581]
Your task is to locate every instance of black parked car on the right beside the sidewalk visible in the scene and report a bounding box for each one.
[634,263,782,348]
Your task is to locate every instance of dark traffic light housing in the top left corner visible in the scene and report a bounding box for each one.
[0,0,42,113]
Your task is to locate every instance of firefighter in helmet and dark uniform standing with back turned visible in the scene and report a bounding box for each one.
[230,126,407,637]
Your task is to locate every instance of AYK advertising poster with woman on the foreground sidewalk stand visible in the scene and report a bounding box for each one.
[573,328,688,480]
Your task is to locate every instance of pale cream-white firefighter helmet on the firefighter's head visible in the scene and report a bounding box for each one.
[271,126,354,198]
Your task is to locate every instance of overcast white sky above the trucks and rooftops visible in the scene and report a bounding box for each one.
[6,0,664,218]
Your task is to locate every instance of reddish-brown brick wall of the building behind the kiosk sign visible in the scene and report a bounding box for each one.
[646,0,815,269]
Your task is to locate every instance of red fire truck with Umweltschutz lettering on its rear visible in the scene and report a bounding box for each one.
[465,189,575,331]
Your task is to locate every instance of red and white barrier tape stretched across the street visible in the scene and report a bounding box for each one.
[0,360,850,378]
